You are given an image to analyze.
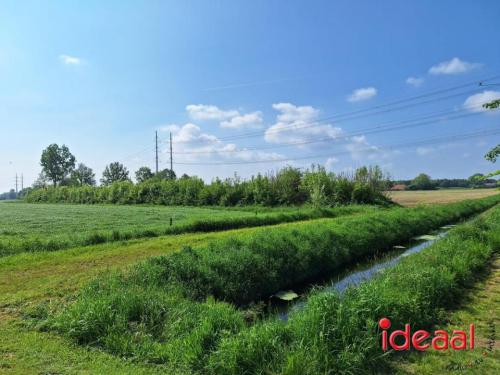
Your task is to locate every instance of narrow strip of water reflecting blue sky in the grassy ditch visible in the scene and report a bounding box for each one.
[269,226,452,320]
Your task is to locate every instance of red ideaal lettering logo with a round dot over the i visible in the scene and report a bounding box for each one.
[378,318,474,350]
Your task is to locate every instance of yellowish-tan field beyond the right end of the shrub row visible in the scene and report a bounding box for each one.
[387,189,500,207]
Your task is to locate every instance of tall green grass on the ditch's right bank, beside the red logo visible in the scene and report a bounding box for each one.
[209,207,500,375]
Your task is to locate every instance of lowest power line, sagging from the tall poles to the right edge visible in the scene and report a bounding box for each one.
[175,129,500,166]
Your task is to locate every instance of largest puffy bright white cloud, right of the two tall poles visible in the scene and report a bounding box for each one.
[264,103,342,148]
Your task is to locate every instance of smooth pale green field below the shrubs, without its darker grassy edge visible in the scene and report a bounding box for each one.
[0,202,250,253]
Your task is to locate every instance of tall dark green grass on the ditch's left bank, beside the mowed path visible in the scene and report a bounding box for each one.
[132,197,500,305]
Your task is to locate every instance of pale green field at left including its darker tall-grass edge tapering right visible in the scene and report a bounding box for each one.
[0,202,376,256]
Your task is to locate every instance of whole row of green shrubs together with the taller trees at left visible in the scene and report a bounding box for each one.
[26,144,389,206]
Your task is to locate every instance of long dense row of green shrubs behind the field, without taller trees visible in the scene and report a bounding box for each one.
[26,166,388,207]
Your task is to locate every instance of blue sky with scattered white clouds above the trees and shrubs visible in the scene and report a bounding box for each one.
[0,1,500,191]
